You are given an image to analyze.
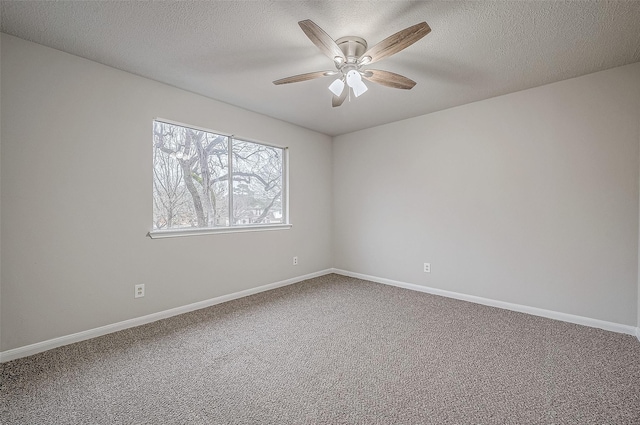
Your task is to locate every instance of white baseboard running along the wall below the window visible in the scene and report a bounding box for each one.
[0,269,333,363]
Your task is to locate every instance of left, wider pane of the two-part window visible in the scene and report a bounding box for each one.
[153,121,229,230]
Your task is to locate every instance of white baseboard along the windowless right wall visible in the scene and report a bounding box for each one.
[333,269,640,340]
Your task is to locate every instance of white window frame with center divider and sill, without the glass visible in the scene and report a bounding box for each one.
[147,118,293,239]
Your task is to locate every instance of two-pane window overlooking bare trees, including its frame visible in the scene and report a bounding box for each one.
[150,120,290,237]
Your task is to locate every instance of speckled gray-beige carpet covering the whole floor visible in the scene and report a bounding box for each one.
[0,275,640,425]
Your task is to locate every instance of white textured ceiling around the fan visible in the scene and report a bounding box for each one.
[1,0,640,136]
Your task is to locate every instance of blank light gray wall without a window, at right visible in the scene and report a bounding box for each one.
[333,63,640,326]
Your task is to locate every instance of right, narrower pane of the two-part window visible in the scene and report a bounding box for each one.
[232,140,284,225]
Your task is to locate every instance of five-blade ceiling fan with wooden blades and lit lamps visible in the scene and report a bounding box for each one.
[273,19,431,107]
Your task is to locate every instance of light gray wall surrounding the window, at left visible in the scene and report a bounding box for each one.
[0,34,332,351]
